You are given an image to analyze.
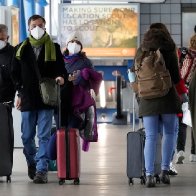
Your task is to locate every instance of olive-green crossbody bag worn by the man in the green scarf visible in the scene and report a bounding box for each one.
[35,64,59,106]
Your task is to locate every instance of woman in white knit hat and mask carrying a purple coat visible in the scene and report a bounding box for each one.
[61,33,102,151]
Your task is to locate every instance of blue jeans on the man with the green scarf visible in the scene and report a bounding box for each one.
[21,110,54,172]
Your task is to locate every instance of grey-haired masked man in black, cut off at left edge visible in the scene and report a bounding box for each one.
[0,24,15,106]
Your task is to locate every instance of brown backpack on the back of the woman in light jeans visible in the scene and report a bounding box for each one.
[134,49,172,99]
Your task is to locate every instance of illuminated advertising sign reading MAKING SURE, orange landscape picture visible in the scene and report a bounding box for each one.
[58,4,139,58]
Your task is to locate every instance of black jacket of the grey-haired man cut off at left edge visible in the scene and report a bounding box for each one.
[0,43,15,102]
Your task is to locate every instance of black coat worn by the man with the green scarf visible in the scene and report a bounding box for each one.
[12,39,67,111]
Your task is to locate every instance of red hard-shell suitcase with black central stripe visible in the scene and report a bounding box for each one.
[57,128,80,185]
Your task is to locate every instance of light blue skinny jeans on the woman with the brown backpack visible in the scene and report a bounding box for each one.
[143,114,177,176]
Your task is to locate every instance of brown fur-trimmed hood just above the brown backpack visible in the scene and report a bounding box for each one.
[141,29,176,51]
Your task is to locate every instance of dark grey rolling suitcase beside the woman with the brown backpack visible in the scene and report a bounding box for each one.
[127,94,161,185]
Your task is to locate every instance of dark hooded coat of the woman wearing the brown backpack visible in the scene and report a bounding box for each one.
[136,29,181,116]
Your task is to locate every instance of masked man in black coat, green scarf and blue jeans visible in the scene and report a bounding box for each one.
[12,15,67,184]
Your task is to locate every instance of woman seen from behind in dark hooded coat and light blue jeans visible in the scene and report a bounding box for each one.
[132,23,181,187]
